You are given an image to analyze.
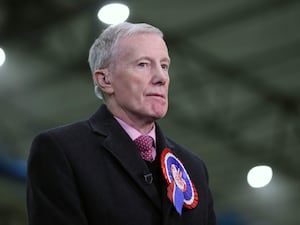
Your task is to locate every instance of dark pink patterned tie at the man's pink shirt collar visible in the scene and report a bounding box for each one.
[134,135,154,162]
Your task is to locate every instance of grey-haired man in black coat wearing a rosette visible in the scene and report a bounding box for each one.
[27,23,216,225]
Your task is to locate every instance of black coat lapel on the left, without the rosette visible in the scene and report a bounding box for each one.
[89,105,161,210]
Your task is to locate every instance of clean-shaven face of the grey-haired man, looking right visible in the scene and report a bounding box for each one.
[109,33,170,122]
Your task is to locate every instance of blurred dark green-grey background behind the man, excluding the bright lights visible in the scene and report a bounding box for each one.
[0,0,300,225]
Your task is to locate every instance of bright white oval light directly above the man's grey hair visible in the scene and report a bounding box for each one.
[97,3,129,24]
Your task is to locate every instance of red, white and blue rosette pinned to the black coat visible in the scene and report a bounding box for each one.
[160,148,198,215]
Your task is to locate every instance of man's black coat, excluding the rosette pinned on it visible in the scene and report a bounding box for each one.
[27,105,216,225]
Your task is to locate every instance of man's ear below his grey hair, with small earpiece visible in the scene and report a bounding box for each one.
[94,69,113,95]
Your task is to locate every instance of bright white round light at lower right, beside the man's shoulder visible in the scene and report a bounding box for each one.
[247,166,273,188]
